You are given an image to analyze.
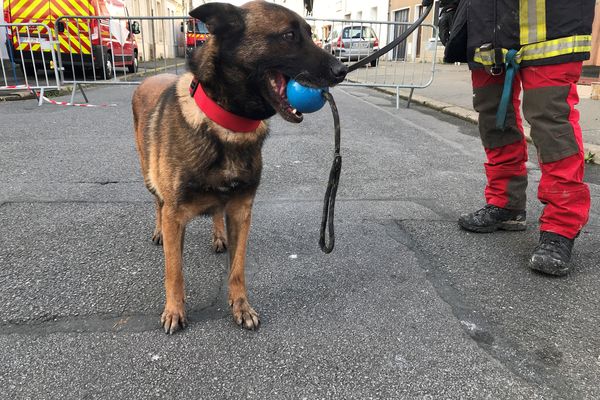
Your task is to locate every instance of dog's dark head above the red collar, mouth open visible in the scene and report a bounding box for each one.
[190,1,348,122]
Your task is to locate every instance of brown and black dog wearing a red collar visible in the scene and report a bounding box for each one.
[133,1,347,333]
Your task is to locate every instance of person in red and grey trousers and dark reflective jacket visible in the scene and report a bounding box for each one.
[423,0,596,276]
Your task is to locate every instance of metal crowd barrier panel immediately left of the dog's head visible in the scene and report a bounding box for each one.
[56,16,196,102]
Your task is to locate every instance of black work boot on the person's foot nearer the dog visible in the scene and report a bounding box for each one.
[458,204,527,233]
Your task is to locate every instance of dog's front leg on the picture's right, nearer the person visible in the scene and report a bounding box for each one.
[225,193,260,329]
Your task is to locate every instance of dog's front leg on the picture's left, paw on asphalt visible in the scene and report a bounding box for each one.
[160,204,187,334]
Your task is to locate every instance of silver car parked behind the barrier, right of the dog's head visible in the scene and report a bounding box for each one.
[323,25,379,67]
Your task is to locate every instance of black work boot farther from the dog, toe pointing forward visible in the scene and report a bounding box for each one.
[529,231,575,276]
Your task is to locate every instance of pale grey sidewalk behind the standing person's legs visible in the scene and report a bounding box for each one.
[400,64,600,159]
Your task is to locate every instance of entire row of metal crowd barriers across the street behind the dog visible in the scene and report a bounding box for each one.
[0,16,441,107]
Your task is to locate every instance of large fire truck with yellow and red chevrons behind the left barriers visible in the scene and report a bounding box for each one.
[4,0,140,79]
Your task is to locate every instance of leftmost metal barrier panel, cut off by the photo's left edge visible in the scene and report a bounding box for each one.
[0,22,61,105]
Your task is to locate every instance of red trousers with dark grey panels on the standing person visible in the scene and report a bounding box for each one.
[472,62,590,238]
